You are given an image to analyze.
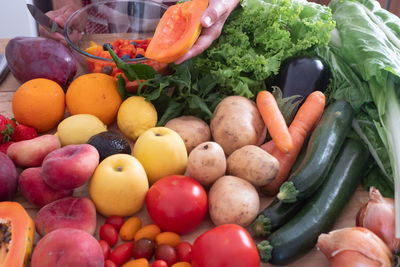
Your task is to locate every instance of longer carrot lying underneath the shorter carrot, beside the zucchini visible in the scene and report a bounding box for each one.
[261,91,325,196]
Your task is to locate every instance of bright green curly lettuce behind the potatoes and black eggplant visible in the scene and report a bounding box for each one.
[194,0,335,98]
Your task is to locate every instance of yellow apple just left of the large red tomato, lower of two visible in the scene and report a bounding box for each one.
[89,154,149,217]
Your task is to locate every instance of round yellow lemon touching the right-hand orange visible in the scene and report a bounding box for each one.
[117,96,157,141]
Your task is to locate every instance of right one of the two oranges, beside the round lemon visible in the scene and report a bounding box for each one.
[66,73,122,125]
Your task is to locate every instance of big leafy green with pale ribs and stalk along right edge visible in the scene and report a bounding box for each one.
[329,0,400,237]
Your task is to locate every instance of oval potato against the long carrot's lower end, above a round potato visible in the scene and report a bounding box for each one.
[227,145,279,186]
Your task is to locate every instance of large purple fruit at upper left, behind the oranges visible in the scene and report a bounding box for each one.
[5,37,77,88]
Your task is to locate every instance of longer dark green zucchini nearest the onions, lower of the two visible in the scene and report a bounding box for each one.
[257,139,369,265]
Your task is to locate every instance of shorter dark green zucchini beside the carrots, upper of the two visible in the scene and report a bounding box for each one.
[278,100,354,203]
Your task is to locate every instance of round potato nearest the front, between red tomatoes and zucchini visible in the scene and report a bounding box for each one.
[208,175,260,227]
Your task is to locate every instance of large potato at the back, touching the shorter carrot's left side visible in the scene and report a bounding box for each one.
[210,96,267,155]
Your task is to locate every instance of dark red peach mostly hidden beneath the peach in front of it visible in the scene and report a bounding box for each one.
[18,167,73,207]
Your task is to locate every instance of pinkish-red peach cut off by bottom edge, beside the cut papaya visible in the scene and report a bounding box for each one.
[31,228,104,267]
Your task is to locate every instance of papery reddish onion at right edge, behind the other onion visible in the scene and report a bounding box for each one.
[356,187,400,252]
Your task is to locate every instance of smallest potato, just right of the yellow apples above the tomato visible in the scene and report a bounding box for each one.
[187,141,226,186]
